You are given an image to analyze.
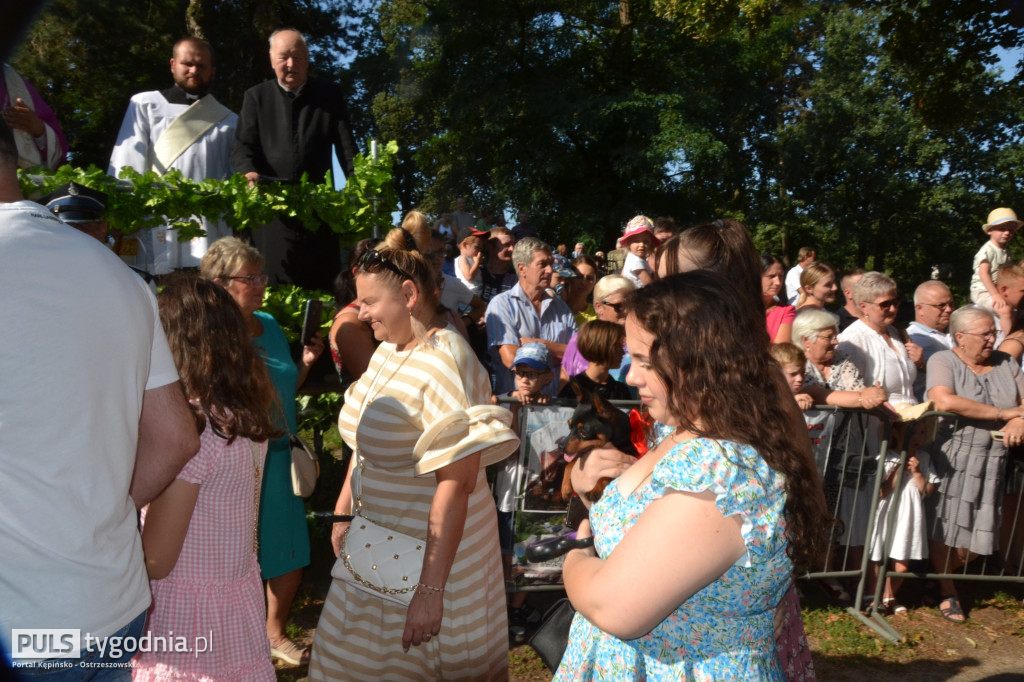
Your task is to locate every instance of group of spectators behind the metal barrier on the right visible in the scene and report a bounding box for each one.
[763,208,1024,623]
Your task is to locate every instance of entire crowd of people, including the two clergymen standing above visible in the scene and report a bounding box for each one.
[0,25,1024,681]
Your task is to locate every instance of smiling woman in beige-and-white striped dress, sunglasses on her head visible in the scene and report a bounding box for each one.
[309,220,518,682]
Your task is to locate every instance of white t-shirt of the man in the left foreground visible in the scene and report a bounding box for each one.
[0,201,178,651]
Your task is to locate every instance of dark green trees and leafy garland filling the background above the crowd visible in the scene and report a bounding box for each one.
[12,0,1024,292]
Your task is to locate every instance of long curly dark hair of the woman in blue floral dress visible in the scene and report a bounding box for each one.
[627,270,831,571]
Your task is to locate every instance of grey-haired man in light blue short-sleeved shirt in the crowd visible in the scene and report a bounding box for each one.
[484,237,577,395]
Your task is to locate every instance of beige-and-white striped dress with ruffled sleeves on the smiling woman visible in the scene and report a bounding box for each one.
[309,328,508,682]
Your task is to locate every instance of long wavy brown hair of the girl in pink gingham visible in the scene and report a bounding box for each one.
[157,275,283,442]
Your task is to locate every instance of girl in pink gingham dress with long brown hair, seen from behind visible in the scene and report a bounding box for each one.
[132,279,284,682]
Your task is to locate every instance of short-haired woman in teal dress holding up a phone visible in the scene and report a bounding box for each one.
[200,237,324,666]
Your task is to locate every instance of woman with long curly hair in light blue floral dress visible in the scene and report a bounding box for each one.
[555,271,828,680]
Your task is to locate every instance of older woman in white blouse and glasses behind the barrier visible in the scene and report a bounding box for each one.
[838,272,924,406]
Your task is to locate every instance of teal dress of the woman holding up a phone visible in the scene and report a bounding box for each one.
[252,311,309,580]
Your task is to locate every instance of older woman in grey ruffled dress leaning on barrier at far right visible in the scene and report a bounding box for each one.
[928,305,1024,623]
